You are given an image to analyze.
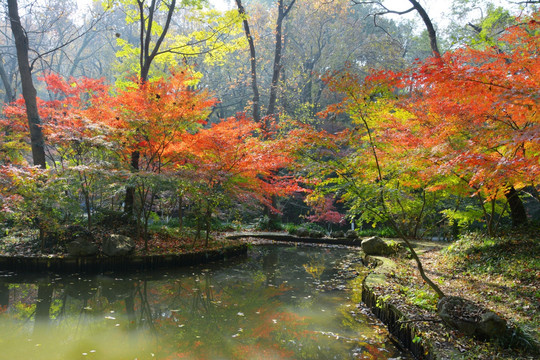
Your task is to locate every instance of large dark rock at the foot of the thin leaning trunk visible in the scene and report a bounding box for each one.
[437,296,507,340]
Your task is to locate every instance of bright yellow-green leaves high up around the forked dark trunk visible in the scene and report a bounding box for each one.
[115,1,245,89]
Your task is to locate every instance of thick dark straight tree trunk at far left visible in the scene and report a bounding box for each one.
[8,0,47,169]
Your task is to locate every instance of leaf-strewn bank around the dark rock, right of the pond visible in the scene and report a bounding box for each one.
[382,234,540,359]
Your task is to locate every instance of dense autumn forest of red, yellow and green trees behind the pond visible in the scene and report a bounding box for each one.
[0,0,540,250]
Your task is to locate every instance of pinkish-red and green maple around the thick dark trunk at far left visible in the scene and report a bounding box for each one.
[2,74,111,242]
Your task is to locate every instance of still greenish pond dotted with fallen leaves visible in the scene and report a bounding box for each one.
[0,245,409,360]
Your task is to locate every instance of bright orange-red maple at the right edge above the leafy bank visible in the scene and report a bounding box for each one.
[390,12,540,233]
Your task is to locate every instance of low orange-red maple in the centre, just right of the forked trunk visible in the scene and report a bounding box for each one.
[179,114,302,245]
